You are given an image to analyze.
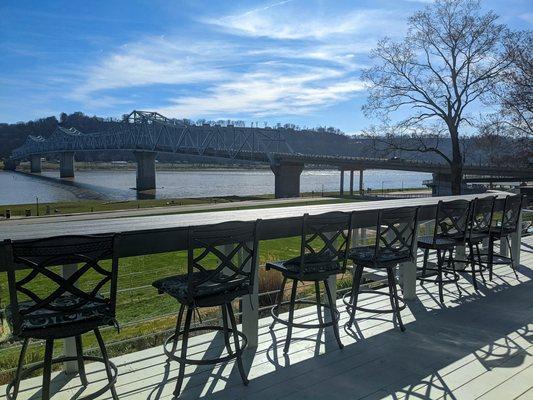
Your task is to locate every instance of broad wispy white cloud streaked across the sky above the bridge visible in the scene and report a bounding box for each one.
[69,0,406,118]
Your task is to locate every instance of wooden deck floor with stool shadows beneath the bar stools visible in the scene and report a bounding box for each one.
[4,237,533,400]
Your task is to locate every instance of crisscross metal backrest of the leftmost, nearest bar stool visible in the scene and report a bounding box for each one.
[6,235,118,335]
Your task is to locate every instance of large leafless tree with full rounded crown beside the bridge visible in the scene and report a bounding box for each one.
[363,0,511,194]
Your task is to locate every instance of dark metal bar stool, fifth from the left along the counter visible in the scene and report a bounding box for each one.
[417,200,471,303]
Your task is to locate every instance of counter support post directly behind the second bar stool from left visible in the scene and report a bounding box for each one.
[239,242,259,348]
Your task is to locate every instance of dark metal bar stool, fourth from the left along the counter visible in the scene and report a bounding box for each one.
[343,207,418,331]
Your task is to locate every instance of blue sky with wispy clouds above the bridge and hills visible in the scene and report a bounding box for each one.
[0,0,533,133]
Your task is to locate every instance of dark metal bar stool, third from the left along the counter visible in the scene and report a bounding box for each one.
[266,212,351,353]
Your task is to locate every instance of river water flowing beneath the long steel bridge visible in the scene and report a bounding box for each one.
[0,169,431,205]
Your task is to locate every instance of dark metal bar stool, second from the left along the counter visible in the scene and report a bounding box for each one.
[152,220,260,397]
